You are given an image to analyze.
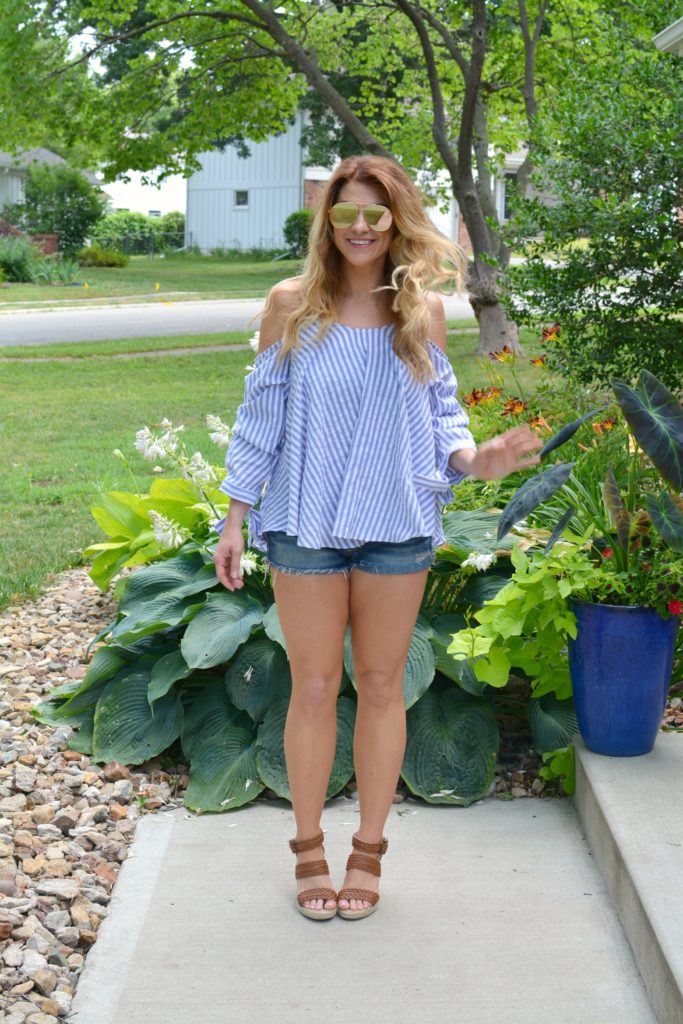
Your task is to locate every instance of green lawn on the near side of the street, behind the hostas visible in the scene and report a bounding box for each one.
[0,332,539,608]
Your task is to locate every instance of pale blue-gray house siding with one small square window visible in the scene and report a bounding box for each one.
[185,115,303,253]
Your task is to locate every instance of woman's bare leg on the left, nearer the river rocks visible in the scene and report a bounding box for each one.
[273,570,349,909]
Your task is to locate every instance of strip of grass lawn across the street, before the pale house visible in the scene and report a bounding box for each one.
[0,256,301,308]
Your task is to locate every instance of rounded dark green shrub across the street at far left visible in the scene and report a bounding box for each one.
[3,164,108,255]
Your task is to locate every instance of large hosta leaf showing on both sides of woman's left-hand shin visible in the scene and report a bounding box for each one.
[256,697,356,801]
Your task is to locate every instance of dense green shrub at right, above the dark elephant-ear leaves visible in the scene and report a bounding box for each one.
[506,57,683,388]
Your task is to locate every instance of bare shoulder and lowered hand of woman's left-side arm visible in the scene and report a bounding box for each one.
[213,279,298,590]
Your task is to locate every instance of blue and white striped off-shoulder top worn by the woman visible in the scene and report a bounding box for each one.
[214,324,476,551]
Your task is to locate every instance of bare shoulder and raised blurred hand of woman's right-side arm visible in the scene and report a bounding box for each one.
[427,292,543,480]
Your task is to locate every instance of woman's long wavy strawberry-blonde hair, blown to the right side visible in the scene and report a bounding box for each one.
[261,157,468,381]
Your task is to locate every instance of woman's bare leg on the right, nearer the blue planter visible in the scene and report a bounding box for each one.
[339,569,428,910]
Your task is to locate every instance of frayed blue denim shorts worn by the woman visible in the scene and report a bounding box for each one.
[263,529,436,575]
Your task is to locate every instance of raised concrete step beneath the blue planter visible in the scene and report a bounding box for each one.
[573,732,683,1024]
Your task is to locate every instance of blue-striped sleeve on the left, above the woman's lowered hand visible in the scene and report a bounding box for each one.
[214,340,290,531]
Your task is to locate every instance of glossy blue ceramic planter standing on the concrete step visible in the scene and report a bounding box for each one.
[569,600,679,758]
